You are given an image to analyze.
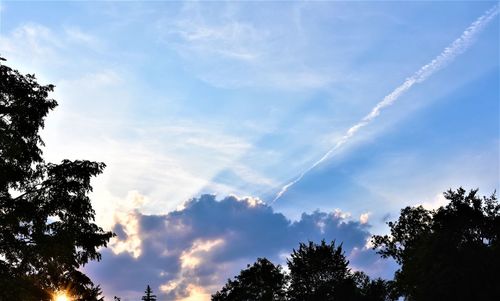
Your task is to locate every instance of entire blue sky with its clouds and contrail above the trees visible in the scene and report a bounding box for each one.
[0,0,500,301]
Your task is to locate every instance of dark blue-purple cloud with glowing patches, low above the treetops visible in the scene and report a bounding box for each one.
[86,195,394,301]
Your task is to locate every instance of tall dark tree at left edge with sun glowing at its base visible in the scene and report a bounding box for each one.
[0,58,113,301]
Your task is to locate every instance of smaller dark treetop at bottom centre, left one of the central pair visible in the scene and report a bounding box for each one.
[212,258,286,301]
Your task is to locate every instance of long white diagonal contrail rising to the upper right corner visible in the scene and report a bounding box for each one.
[271,5,499,204]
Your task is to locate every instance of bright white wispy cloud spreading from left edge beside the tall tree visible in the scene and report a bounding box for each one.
[0,17,282,227]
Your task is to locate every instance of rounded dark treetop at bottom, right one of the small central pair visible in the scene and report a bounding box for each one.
[288,240,357,301]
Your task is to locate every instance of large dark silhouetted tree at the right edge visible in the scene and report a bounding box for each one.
[373,188,500,300]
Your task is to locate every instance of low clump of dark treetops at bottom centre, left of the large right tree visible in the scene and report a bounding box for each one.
[212,240,398,301]
